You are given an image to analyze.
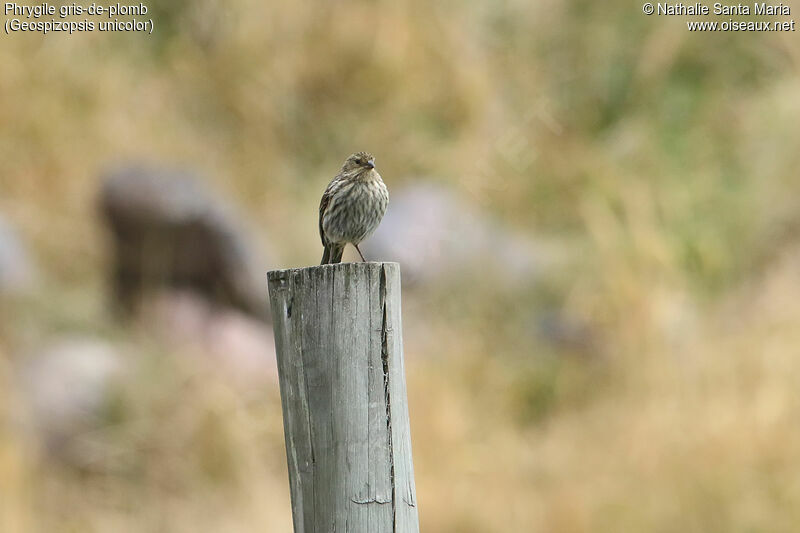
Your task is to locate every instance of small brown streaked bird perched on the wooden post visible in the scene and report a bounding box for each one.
[319,152,389,265]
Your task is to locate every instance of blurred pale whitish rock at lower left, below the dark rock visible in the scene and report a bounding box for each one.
[20,337,126,464]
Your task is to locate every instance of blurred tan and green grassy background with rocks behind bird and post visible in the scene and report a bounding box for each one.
[0,0,800,533]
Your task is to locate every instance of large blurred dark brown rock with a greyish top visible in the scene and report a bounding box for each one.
[100,166,269,319]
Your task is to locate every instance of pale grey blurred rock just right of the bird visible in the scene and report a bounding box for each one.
[362,184,552,287]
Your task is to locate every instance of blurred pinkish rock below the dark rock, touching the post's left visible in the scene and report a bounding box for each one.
[147,291,278,385]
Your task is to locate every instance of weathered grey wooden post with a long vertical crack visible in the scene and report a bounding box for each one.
[268,263,419,533]
